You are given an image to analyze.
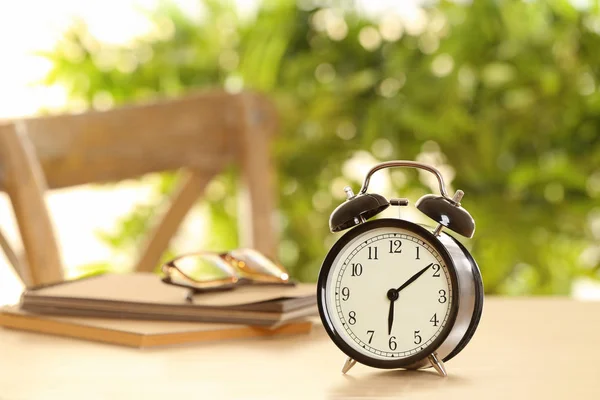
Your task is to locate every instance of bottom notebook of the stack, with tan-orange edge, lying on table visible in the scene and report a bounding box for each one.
[0,306,312,347]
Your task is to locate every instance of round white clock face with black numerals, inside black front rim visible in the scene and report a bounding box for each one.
[319,220,456,366]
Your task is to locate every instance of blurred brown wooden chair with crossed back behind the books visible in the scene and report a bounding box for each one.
[0,92,276,286]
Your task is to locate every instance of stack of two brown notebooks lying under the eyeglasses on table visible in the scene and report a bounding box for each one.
[0,273,316,347]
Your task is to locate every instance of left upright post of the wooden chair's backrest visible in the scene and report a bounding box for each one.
[0,122,63,287]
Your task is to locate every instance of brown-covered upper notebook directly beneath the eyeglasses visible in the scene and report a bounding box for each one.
[21,273,317,326]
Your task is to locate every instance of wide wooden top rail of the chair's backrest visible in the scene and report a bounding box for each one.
[21,92,243,188]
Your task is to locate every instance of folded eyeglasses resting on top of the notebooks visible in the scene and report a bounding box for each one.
[161,249,295,294]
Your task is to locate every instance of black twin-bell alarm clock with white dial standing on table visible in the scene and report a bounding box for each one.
[317,161,483,376]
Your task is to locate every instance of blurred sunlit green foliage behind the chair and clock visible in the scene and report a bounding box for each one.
[46,0,600,294]
